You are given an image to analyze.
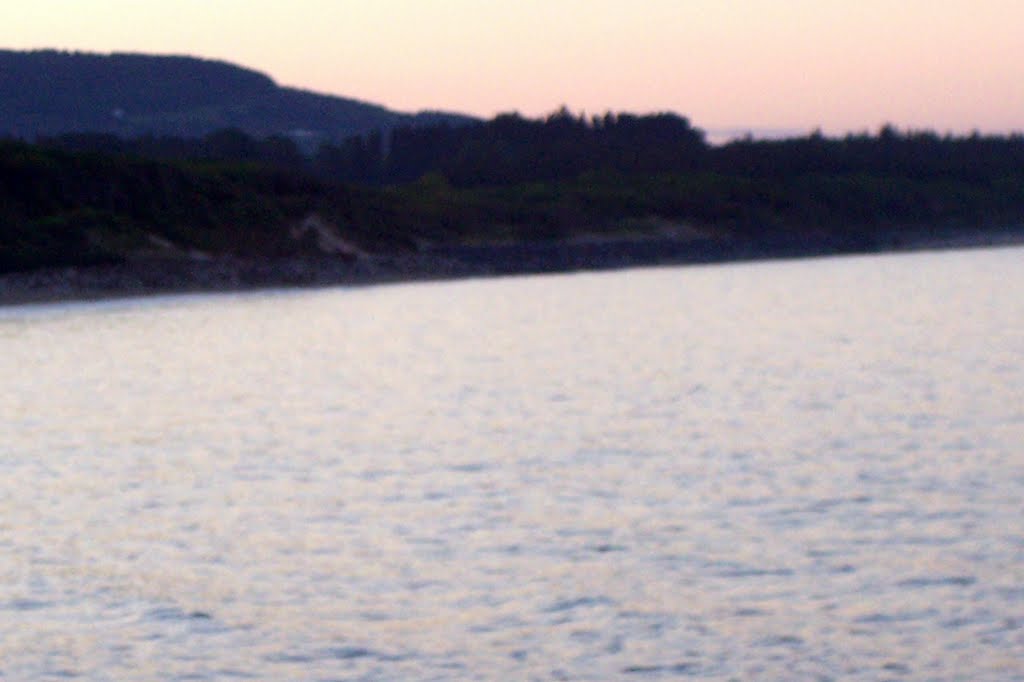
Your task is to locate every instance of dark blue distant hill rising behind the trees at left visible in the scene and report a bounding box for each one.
[0,50,472,144]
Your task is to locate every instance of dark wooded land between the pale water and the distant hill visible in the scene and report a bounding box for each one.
[0,62,1024,302]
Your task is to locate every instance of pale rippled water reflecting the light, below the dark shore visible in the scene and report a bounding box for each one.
[0,249,1024,680]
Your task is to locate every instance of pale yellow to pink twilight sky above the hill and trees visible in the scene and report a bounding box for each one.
[0,0,1024,133]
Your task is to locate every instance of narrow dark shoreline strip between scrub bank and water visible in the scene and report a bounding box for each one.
[0,225,1024,307]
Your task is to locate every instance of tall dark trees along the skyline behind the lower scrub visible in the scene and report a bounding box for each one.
[40,110,1024,187]
